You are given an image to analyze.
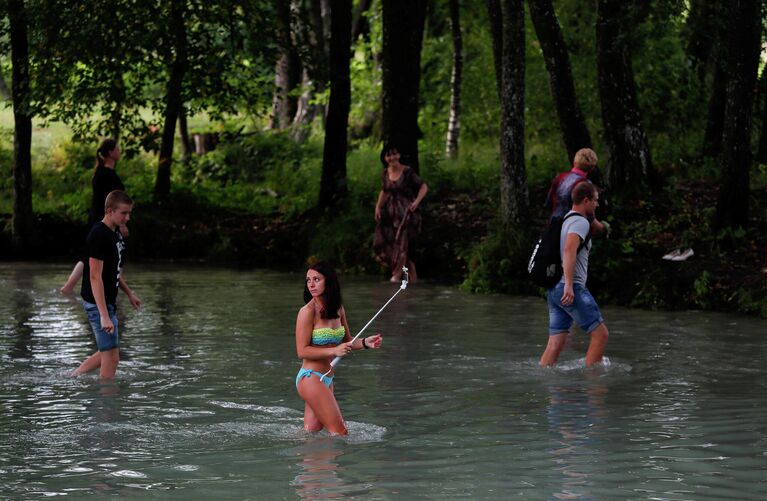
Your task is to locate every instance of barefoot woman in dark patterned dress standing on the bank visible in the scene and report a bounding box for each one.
[373,146,429,282]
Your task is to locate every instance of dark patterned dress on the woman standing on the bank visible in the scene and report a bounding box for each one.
[373,167,423,270]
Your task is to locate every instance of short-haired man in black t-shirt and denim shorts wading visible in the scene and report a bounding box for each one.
[74,190,141,378]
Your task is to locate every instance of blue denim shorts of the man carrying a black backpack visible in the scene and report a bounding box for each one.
[547,282,604,336]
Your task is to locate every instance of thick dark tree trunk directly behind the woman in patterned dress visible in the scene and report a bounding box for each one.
[381,0,427,172]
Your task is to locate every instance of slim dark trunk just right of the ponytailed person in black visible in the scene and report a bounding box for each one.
[154,0,187,201]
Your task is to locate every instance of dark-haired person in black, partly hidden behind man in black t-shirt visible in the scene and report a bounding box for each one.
[59,139,128,294]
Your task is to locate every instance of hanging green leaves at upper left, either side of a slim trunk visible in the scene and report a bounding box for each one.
[21,0,280,150]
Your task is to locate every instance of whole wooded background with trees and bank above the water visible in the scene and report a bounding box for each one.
[0,0,767,317]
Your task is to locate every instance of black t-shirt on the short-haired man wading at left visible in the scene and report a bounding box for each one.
[80,222,125,305]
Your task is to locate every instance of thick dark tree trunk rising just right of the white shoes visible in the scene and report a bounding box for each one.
[716,0,761,228]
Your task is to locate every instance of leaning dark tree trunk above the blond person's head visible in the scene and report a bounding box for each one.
[527,0,592,162]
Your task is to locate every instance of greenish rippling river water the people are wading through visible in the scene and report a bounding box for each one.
[0,263,767,501]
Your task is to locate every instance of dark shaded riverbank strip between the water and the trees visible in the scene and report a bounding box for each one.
[0,176,767,318]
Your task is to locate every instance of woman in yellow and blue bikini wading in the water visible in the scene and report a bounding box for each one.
[296,262,382,435]
